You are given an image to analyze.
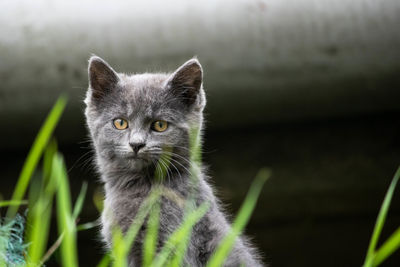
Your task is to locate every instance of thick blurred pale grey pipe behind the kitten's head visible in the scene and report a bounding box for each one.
[0,0,400,146]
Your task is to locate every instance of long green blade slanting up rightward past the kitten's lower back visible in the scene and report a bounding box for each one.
[207,169,270,267]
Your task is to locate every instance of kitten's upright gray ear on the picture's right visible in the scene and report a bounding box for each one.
[168,58,205,108]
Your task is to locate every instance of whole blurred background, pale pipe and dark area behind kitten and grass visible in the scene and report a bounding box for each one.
[0,0,400,267]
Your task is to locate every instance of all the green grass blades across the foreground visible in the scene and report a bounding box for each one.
[0,97,400,267]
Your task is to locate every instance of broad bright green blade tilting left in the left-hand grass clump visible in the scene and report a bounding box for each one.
[53,154,78,267]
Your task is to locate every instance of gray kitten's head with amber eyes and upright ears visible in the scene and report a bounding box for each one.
[85,56,206,181]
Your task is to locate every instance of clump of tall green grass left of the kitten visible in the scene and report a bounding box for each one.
[0,96,86,267]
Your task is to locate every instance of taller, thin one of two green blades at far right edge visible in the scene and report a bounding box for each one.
[364,167,400,266]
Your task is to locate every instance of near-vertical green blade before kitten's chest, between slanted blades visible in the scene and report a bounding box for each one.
[143,201,160,267]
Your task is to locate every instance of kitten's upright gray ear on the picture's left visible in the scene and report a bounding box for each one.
[88,56,119,100]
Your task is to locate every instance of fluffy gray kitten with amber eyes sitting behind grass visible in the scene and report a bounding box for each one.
[85,56,262,266]
